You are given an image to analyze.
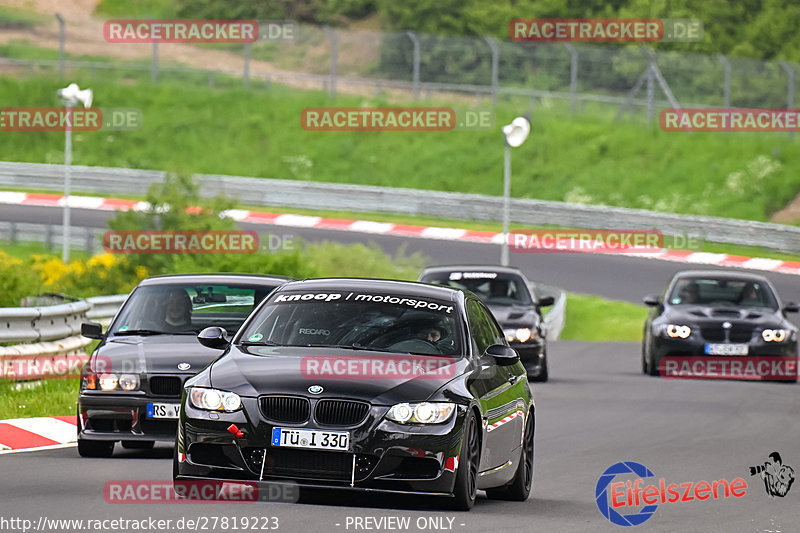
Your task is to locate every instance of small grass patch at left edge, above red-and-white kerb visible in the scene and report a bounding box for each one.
[0,379,80,420]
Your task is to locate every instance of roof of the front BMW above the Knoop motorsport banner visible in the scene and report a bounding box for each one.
[279,278,467,301]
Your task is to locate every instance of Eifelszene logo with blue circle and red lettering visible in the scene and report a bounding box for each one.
[595,461,748,526]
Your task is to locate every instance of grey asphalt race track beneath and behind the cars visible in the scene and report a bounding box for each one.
[0,206,800,533]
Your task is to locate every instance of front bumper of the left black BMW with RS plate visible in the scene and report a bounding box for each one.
[78,392,180,442]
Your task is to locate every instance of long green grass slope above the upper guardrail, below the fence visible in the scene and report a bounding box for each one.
[0,71,800,220]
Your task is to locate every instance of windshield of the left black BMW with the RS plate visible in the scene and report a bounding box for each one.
[111,284,274,335]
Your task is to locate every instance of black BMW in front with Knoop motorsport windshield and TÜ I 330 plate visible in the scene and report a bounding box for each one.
[174,279,535,510]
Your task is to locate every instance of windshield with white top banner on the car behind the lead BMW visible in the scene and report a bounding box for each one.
[420,271,533,305]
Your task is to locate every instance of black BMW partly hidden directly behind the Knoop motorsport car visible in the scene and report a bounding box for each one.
[418,265,554,381]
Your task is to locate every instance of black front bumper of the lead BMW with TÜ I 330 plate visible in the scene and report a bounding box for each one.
[177,398,466,495]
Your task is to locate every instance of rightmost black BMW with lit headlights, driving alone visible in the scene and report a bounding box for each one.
[642,270,799,376]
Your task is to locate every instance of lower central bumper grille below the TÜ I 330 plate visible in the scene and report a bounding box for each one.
[242,448,378,481]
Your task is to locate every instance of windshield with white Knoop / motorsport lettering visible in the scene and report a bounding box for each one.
[241,292,464,355]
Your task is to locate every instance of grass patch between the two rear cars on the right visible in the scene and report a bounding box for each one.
[560,293,647,342]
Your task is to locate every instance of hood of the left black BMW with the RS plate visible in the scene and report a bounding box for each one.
[94,335,222,375]
